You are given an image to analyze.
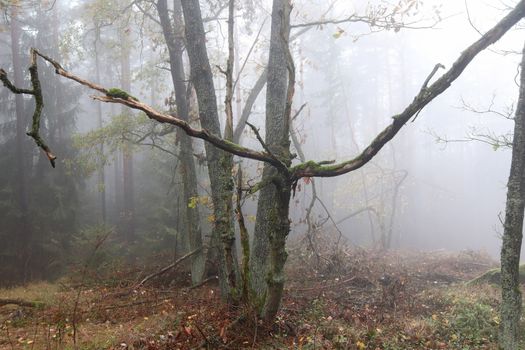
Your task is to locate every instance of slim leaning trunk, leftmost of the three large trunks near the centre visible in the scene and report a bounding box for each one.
[157,0,206,285]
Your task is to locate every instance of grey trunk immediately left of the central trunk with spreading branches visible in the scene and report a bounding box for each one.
[182,0,238,300]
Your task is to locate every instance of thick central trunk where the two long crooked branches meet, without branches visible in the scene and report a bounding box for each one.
[251,0,295,319]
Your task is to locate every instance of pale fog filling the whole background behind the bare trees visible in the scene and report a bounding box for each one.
[0,0,522,282]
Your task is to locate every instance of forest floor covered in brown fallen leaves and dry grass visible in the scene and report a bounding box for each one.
[0,237,520,350]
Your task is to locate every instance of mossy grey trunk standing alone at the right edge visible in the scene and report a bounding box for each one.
[499,43,525,350]
